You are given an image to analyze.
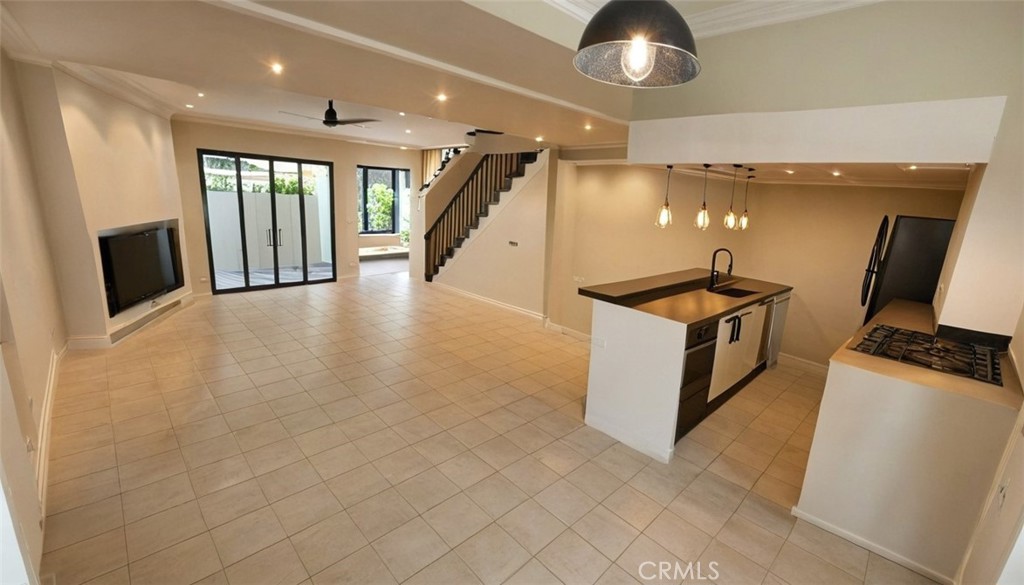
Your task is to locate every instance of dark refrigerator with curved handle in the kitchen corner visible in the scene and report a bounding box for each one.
[860,215,955,323]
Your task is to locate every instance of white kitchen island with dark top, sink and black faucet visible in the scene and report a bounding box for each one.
[580,268,793,462]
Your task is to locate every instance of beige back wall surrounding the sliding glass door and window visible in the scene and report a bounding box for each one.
[171,120,423,293]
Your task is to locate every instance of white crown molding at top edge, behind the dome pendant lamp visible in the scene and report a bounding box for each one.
[544,0,882,39]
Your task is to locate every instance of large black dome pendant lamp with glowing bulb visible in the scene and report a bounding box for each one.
[572,0,700,87]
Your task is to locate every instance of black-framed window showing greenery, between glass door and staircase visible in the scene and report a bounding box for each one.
[355,166,411,234]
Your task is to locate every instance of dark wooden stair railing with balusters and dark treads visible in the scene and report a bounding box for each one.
[423,152,538,282]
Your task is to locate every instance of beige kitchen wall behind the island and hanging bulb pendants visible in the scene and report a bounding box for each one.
[550,165,963,364]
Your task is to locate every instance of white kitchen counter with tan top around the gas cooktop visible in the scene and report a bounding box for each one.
[793,300,1024,583]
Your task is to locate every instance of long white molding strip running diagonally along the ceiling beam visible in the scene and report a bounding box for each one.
[202,0,629,125]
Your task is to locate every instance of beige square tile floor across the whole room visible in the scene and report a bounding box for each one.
[42,274,928,585]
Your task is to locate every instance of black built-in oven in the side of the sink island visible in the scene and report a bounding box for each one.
[676,322,718,442]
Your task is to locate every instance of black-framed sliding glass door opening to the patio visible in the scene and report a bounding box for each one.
[199,150,337,293]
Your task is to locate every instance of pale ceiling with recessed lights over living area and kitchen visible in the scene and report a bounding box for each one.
[0,0,966,189]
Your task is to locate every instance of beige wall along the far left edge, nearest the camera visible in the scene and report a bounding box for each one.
[0,52,67,574]
